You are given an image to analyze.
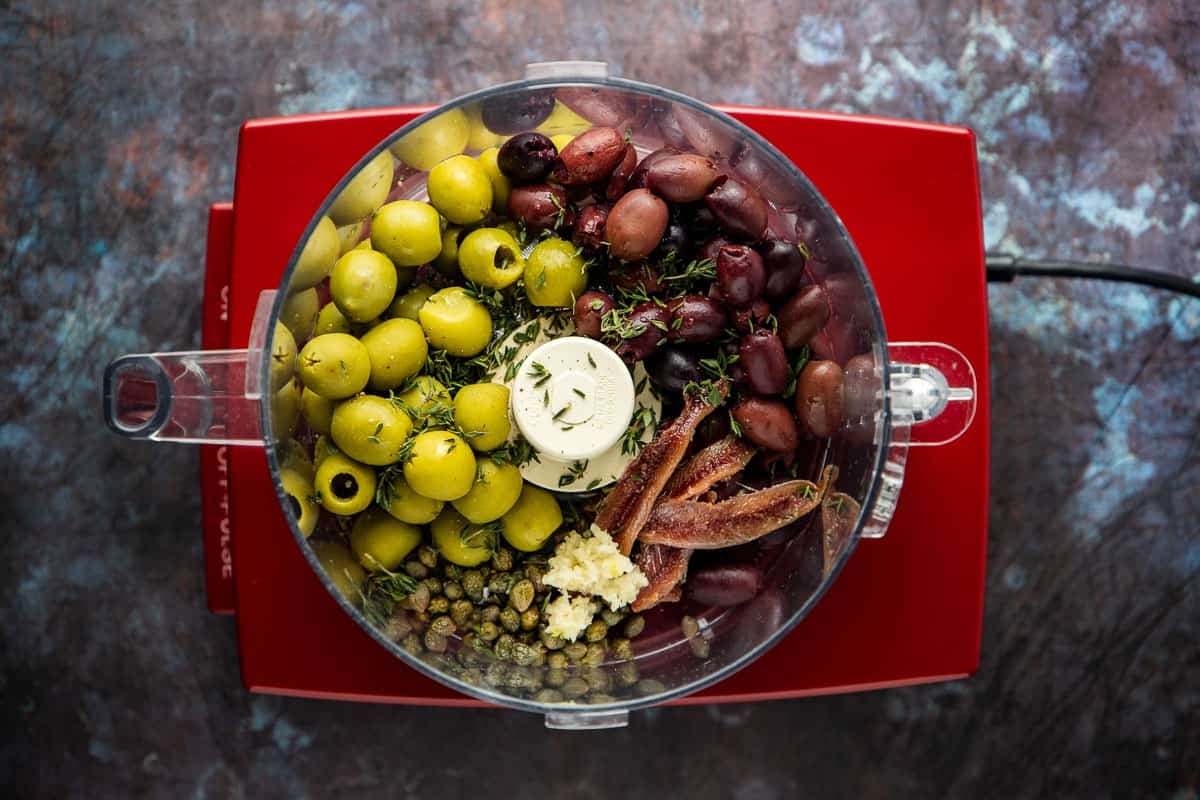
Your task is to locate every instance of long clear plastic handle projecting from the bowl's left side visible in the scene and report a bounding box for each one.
[103,291,275,447]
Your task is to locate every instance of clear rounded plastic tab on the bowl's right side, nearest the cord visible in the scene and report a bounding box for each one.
[862,342,978,539]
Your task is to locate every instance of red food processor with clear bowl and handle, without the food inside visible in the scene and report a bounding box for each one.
[104,62,988,728]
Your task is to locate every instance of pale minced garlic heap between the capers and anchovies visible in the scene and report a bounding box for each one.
[541,525,649,610]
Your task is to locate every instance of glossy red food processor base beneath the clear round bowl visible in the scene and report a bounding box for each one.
[202,107,989,705]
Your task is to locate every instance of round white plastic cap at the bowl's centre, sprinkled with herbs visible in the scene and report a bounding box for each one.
[512,336,635,461]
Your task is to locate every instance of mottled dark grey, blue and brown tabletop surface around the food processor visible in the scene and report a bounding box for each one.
[0,0,1200,800]
